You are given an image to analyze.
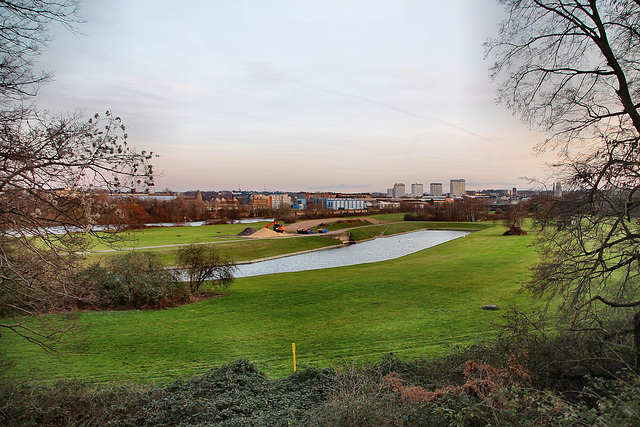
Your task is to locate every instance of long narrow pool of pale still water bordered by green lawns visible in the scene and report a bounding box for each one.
[236,230,469,277]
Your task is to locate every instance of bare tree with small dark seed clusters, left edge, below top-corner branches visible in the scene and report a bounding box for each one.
[0,112,153,348]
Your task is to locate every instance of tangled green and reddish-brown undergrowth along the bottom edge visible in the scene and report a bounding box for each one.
[0,338,640,426]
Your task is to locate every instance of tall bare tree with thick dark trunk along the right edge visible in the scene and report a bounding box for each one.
[487,0,640,366]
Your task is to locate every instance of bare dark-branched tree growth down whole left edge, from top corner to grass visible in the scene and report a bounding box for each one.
[0,0,153,347]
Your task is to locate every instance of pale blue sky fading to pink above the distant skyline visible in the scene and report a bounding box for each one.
[36,0,548,192]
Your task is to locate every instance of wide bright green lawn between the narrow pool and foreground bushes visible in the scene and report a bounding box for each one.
[2,227,535,382]
